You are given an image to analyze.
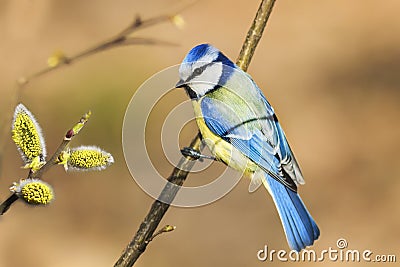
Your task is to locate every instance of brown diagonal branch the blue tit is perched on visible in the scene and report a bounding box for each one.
[114,0,275,267]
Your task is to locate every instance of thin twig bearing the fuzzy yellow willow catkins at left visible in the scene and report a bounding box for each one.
[0,111,90,215]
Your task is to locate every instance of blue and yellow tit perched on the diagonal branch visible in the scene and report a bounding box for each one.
[176,44,320,251]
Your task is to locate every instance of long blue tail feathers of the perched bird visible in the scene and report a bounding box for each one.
[266,176,319,251]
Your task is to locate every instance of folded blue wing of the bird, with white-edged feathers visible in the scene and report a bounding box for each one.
[201,94,297,191]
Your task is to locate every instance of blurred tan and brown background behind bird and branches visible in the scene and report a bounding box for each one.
[0,0,400,267]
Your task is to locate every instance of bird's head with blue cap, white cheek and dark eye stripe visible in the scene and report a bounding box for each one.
[176,44,235,99]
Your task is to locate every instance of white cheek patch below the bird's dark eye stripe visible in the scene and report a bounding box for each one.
[190,62,222,96]
